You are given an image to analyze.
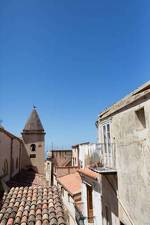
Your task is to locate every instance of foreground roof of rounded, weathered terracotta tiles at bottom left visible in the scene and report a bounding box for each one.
[0,186,66,225]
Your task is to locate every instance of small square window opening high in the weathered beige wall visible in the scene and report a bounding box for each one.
[135,107,146,129]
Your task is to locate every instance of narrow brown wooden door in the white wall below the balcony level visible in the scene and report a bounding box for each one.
[87,185,94,223]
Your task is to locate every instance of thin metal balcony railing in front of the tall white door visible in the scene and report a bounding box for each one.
[96,143,116,169]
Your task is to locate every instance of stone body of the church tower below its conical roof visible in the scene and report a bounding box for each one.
[22,133,45,174]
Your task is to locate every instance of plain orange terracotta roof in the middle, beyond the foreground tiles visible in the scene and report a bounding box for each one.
[57,172,82,196]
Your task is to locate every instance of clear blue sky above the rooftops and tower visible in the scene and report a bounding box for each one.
[0,0,150,148]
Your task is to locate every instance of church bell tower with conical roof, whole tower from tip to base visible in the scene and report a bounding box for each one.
[22,107,45,174]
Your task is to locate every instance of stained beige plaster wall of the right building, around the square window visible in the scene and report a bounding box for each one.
[98,99,150,225]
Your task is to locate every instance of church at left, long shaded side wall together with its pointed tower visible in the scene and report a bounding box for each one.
[0,109,45,182]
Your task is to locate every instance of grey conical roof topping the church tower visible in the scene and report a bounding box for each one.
[23,108,44,132]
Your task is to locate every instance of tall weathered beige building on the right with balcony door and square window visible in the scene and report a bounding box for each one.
[97,82,150,225]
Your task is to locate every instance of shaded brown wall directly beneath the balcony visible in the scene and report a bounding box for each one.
[102,175,118,225]
